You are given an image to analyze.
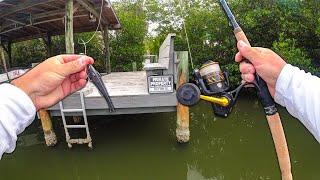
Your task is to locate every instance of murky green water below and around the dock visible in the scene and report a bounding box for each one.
[0,96,320,180]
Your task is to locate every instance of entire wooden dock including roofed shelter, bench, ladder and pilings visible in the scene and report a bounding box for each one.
[0,0,190,147]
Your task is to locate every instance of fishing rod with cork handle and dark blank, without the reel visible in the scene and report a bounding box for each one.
[219,0,292,180]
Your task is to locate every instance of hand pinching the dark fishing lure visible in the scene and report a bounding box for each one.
[12,55,94,110]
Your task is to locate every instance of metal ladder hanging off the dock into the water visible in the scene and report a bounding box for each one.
[59,91,92,149]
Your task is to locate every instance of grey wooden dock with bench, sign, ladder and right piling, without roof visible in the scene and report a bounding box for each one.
[47,34,190,147]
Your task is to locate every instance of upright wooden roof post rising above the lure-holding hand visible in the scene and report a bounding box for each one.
[65,0,74,54]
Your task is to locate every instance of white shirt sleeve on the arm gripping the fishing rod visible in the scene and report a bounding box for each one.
[275,64,320,143]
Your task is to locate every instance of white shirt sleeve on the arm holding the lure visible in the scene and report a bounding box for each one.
[0,84,36,159]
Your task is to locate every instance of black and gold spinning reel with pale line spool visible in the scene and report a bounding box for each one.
[177,61,248,117]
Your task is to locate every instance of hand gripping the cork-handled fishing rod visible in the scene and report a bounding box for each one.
[235,41,286,97]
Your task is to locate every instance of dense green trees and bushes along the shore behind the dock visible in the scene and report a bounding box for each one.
[3,0,320,85]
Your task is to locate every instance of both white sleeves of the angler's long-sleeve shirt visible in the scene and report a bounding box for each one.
[0,64,320,159]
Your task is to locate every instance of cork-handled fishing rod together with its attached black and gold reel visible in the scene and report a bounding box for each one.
[177,0,292,180]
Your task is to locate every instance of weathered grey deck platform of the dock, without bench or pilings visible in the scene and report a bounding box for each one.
[48,71,177,116]
